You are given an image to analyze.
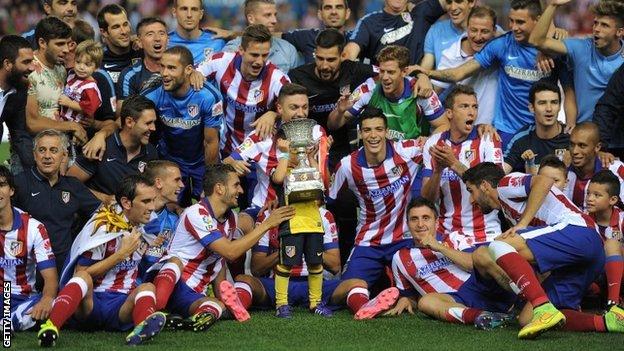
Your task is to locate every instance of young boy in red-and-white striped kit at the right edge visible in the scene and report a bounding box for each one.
[585,170,624,307]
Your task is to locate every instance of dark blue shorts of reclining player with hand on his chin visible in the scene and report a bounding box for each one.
[449,270,518,313]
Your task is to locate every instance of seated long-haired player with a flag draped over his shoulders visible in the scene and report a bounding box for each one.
[37,175,166,347]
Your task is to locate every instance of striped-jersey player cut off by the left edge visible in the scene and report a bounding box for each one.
[0,166,58,331]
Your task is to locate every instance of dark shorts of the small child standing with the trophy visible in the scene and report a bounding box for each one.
[280,233,324,267]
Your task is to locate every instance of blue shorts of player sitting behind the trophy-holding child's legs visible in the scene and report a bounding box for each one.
[259,277,342,307]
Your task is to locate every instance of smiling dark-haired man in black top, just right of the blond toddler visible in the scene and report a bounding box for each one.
[97,4,141,84]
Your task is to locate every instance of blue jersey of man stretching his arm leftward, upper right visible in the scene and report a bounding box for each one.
[474,32,550,133]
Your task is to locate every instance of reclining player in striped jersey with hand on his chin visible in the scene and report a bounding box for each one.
[388,198,516,329]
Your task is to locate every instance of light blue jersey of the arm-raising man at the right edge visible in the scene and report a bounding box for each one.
[563,38,624,123]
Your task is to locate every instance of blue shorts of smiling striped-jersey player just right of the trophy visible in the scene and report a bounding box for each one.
[342,239,414,286]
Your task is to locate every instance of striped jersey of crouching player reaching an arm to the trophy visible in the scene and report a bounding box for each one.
[168,198,237,293]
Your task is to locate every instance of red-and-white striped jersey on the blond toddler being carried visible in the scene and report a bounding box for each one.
[60,71,102,122]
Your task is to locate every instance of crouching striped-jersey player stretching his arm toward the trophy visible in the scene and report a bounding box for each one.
[149,164,294,331]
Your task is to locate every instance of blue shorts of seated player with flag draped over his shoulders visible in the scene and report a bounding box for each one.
[77,292,134,331]
